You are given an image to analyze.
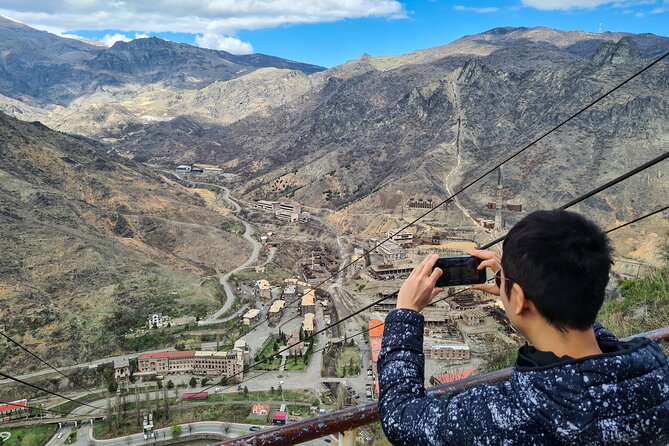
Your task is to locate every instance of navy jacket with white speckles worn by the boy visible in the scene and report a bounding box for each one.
[378,310,669,446]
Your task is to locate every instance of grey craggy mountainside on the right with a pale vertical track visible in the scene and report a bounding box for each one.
[107,28,669,230]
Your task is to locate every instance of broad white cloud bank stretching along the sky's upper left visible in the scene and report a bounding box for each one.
[0,0,407,36]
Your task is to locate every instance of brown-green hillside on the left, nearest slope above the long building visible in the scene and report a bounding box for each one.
[0,114,250,371]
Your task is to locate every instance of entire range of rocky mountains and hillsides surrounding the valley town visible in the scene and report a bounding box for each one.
[0,18,669,367]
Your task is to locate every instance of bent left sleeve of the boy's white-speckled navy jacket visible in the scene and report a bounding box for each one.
[378,310,520,446]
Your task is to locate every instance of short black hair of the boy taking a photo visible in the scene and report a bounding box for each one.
[502,209,613,331]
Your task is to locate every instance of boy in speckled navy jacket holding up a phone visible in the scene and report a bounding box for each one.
[379,210,669,445]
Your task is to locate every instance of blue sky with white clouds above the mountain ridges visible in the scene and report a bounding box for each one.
[0,0,669,67]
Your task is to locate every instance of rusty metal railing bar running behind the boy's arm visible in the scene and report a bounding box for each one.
[222,327,669,446]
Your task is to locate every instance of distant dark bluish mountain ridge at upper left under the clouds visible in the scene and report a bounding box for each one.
[0,17,323,107]
